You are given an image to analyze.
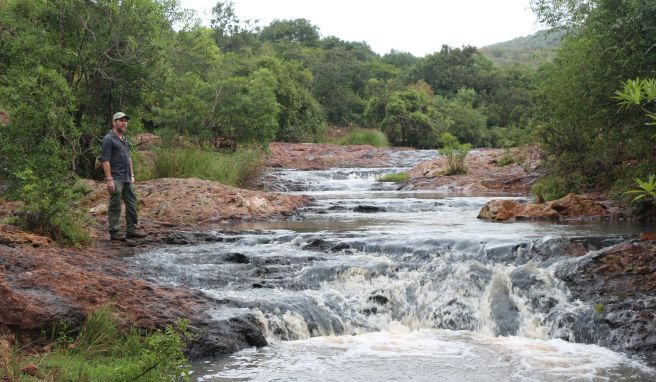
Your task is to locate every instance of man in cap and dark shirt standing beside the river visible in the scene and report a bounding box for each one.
[100,112,147,241]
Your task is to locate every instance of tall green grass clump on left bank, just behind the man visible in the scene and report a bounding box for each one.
[146,148,264,186]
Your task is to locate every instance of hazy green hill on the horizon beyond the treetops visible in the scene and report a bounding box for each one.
[479,31,562,67]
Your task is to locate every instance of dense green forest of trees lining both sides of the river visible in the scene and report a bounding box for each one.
[0,0,656,243]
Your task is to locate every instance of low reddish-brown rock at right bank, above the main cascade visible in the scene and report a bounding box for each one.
[478,194,623,221]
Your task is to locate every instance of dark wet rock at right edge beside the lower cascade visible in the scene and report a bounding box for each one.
[556,241,656,365]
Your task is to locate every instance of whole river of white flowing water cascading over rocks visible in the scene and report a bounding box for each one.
[136,151,656,381]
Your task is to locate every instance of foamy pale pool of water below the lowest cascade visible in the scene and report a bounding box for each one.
[196,324,653,382]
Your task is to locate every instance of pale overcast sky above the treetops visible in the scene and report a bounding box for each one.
[182,0,541,56]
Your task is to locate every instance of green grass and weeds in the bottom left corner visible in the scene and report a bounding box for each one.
[0,307,188,382]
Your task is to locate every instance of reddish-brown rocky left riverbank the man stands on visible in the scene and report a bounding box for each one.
[0,179,309,358]
